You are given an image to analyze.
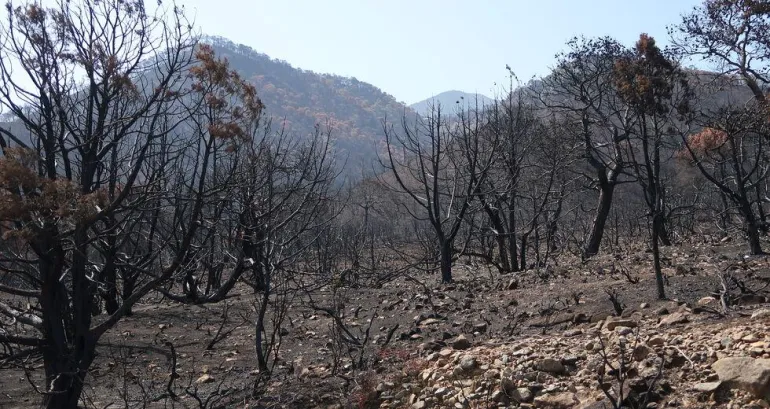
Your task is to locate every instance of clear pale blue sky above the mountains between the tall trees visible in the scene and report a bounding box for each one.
[192,0,702,103]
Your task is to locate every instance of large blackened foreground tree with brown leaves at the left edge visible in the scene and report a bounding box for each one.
[0,0,205,408]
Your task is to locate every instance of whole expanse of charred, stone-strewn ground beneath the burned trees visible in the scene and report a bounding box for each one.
[0,237,770,409]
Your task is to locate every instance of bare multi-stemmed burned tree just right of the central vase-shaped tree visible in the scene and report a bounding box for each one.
[464,79,574,273]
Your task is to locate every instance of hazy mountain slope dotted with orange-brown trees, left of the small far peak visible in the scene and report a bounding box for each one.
[204,37,413,178]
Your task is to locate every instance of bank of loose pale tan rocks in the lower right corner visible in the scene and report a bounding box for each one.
[375,299,770,409]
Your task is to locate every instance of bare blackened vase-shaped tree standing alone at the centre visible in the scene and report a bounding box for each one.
[380,101,497,283]
